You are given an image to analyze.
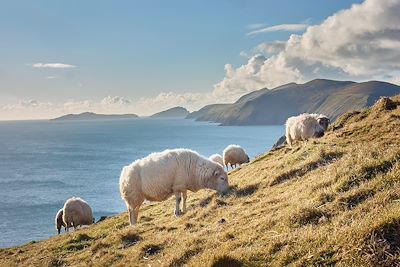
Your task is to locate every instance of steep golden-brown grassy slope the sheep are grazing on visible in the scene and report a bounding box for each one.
[0,97,400,266]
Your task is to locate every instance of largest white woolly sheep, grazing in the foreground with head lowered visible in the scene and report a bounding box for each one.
[119,148,229,226]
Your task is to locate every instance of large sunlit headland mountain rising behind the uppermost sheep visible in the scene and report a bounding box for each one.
[187,79,400,125]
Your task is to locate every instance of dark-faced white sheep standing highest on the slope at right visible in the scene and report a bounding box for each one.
[286,113,324,148]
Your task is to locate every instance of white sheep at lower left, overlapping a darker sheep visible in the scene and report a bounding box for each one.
[62,197,94,232]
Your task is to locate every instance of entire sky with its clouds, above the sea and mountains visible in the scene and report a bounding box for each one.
[0,0,400,120]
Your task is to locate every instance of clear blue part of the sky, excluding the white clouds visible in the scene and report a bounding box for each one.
[4,0,400,119]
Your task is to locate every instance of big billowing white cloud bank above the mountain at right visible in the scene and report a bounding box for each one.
[214,0,400,98]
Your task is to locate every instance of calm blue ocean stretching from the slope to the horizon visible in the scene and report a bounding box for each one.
[0,118,284,247]
